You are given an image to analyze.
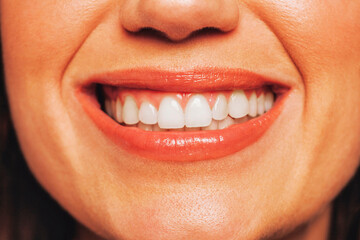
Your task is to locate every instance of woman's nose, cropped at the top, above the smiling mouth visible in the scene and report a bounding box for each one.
[121,0,239,41]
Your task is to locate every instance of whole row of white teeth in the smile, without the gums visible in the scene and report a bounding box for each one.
[105,90,274,131]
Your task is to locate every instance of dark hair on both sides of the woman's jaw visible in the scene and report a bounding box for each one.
[0,56,360,240]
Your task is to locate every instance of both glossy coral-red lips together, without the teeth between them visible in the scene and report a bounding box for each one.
[76,69,290,162]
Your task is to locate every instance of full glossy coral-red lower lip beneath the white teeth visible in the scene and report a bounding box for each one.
[76,90,287,162]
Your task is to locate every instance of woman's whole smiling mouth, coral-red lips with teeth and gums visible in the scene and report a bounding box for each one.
[76,69,290,162]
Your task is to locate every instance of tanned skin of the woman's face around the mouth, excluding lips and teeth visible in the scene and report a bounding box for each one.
[1,0,360,240]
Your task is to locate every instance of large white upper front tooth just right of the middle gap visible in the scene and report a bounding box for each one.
[185,94,212,128]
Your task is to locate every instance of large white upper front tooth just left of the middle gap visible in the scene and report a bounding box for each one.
[158,97,185,129]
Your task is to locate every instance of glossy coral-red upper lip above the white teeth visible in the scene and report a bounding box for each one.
[78,68,289,92]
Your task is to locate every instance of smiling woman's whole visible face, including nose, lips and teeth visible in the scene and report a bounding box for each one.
[1,0,360,240]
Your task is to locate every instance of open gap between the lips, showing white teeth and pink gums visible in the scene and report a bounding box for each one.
[99,85,275,131]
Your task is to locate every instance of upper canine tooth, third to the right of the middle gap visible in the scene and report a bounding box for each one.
[229,90,249,118]
